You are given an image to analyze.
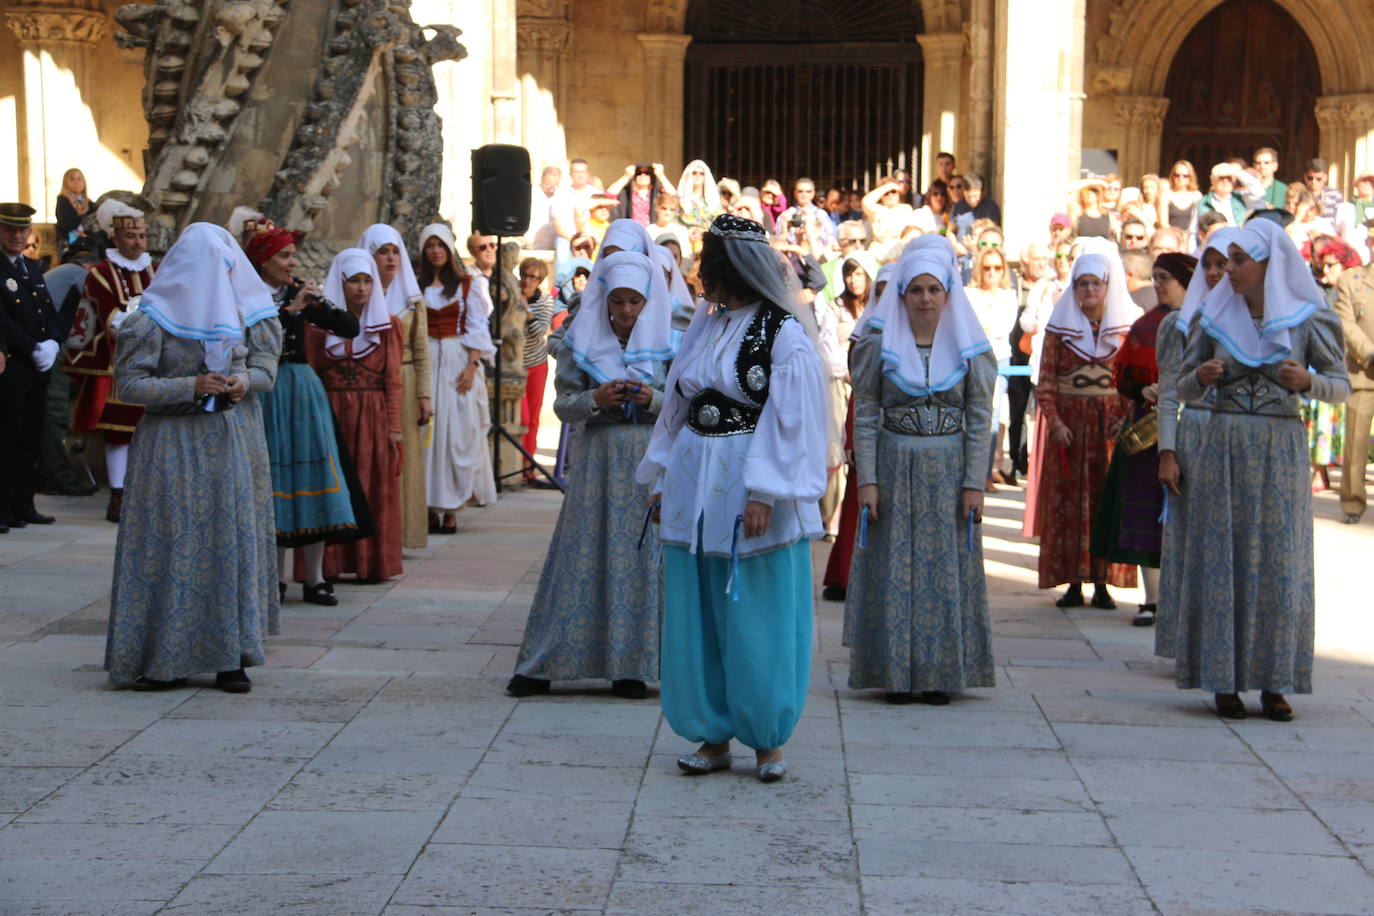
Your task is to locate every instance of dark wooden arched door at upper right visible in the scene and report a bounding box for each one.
[1160,0,1322,177]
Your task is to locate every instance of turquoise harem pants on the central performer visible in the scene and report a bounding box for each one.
[660,540,812,750]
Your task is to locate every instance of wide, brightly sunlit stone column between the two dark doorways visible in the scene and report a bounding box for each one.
[993,0,1084,255]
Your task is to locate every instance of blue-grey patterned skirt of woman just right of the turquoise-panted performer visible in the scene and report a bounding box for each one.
[844,430,995,694]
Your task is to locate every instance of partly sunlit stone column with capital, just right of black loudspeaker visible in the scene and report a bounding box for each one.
[515,16,573,175]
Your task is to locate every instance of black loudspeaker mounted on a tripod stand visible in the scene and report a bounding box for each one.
[473,143,565,490]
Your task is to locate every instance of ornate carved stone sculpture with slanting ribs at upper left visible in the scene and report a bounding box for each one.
[115,0,467,249]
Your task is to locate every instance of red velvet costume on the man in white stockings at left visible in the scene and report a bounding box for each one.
[62,261,154,445]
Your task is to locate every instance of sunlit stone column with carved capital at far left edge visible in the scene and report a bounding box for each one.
[4,0,109,222]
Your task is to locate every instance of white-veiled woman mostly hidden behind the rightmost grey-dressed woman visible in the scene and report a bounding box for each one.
[1154,227,1241,658]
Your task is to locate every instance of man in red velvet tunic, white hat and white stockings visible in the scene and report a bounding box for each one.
[63,201,153,522]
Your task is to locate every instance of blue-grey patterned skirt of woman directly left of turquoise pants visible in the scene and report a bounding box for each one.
[515,424,662,681]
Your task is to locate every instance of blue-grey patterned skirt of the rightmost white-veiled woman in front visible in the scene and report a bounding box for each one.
[1161,413,1316,694]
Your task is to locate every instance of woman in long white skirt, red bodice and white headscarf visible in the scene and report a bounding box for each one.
[420,222,496,534]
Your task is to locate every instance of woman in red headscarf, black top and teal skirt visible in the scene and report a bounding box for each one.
[245,229,371,606]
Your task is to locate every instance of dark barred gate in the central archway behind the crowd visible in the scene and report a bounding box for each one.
[683,0,922,190]
